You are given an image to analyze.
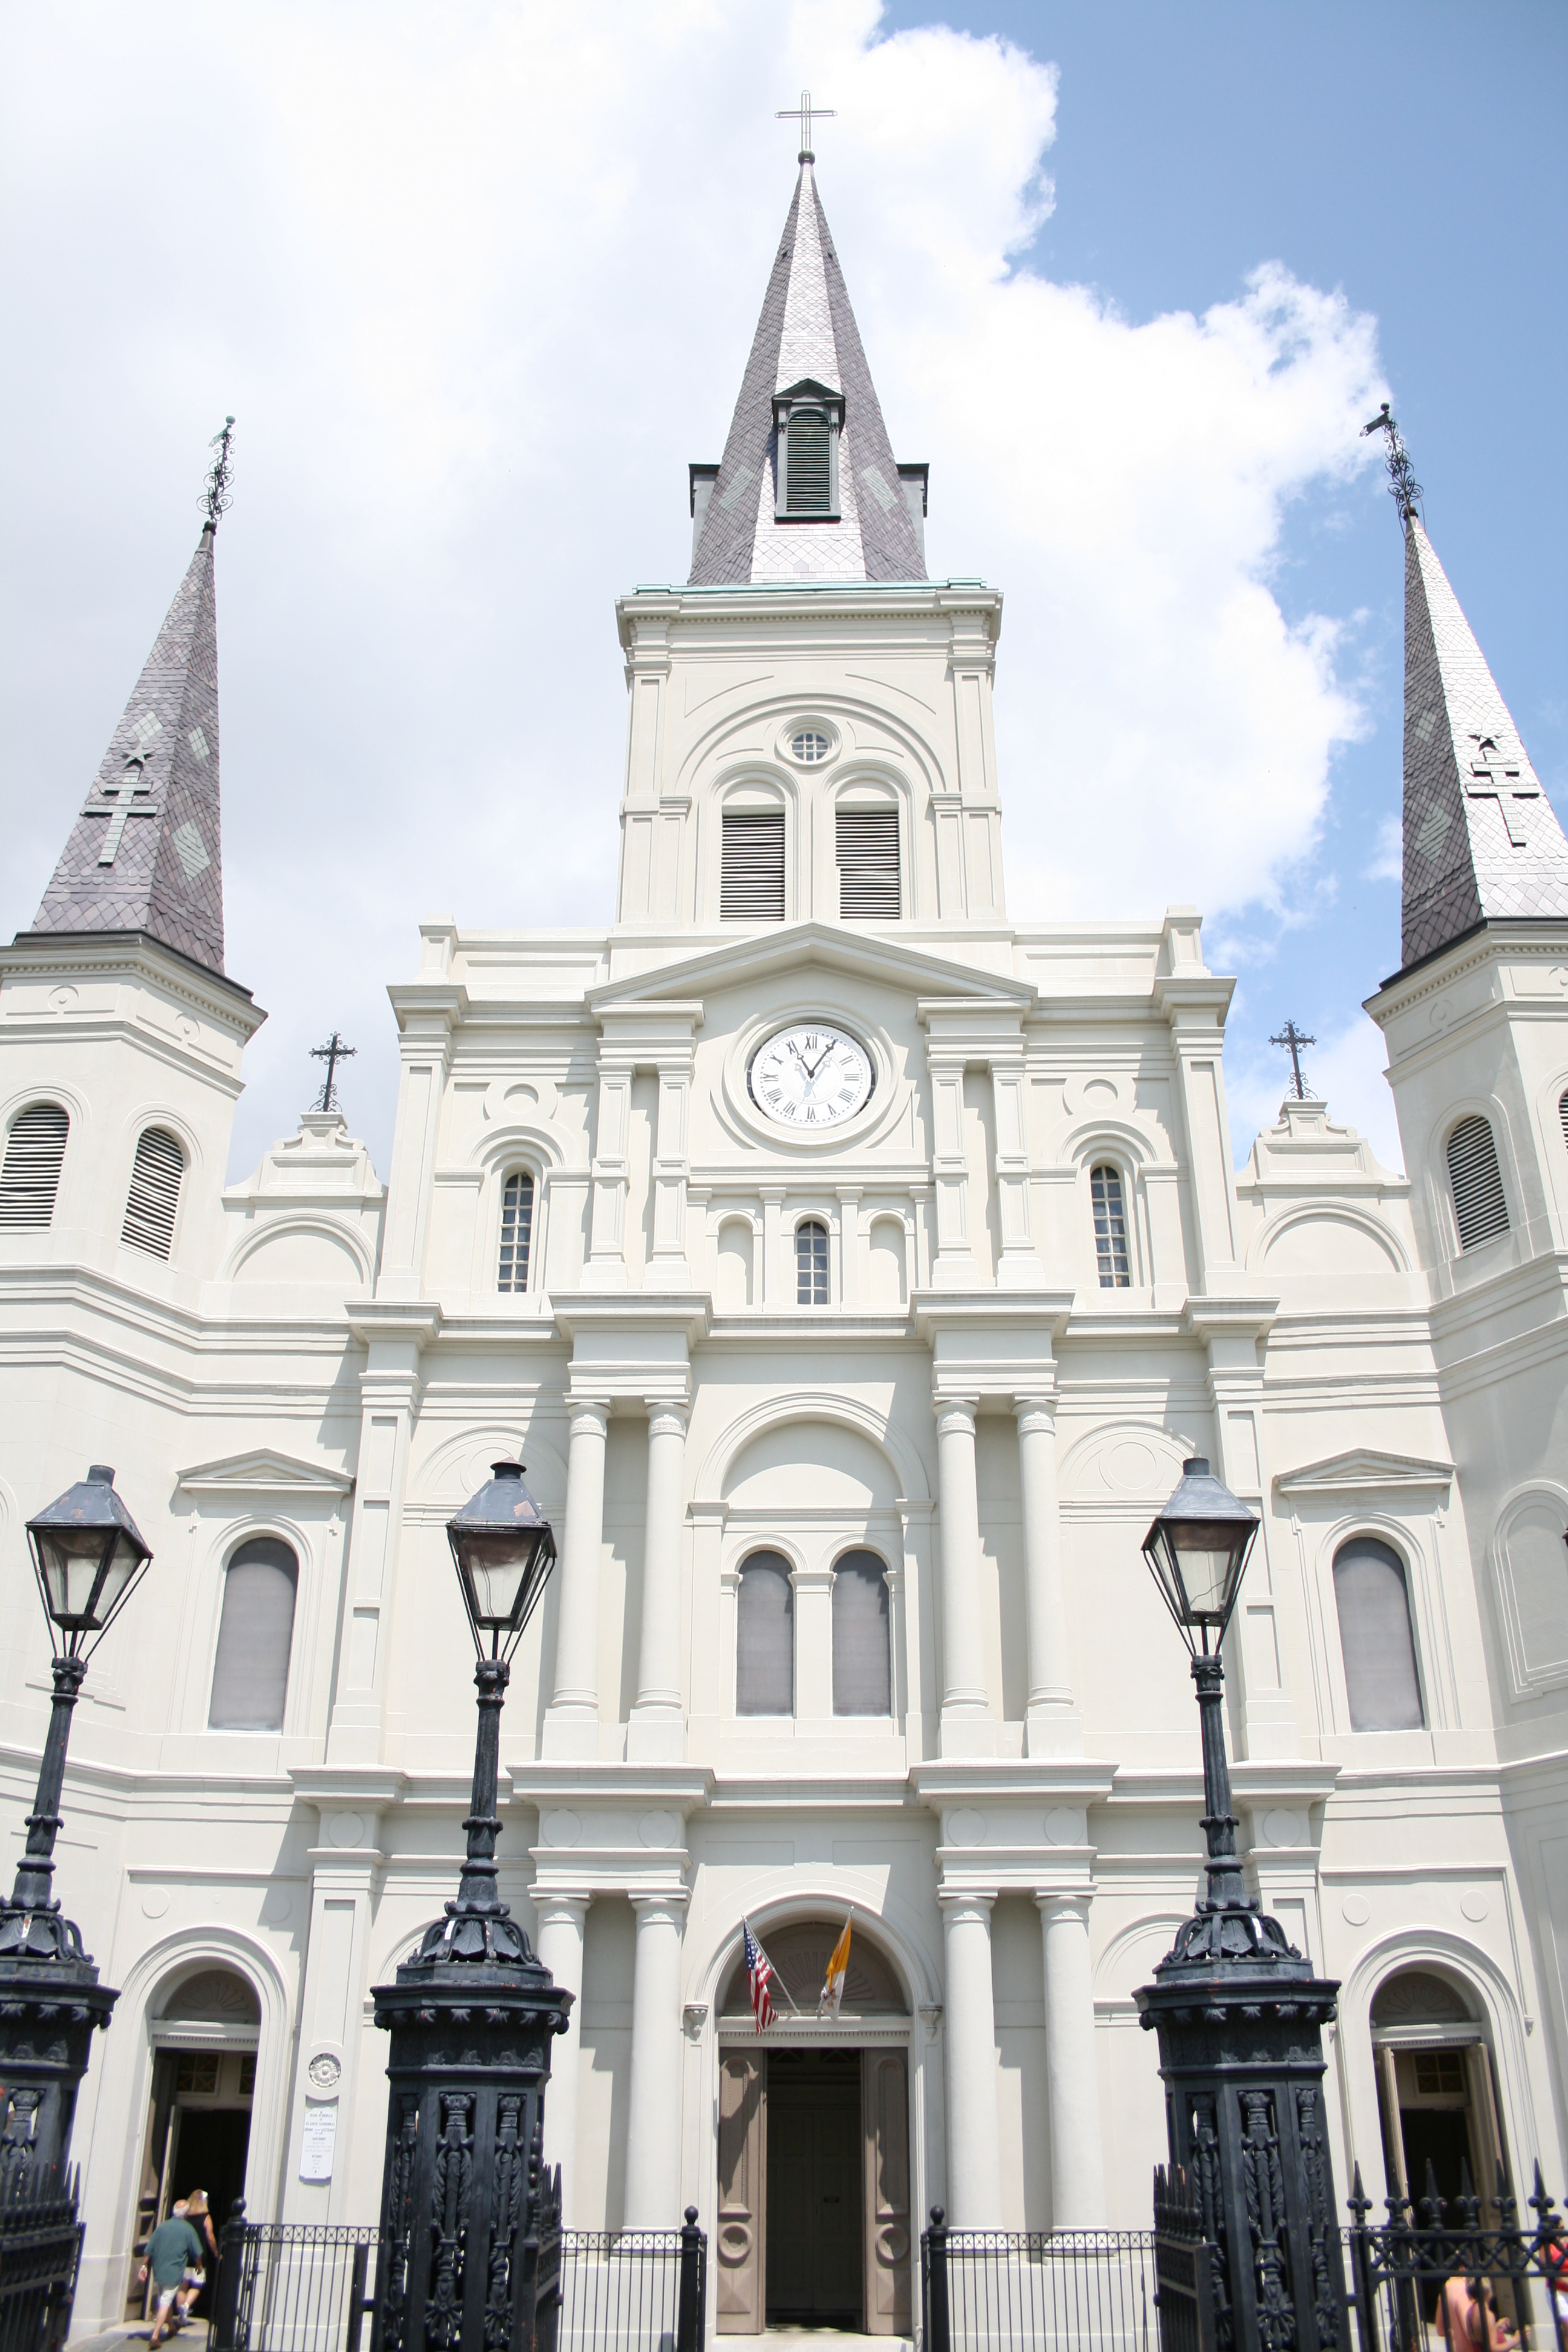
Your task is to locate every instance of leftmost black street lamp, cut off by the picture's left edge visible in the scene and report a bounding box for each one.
[0,1463,153,2195]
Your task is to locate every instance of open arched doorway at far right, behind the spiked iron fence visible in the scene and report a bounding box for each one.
[1373,1968,1502,2220]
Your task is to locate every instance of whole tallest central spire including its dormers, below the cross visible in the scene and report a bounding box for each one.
[691,153,926,588]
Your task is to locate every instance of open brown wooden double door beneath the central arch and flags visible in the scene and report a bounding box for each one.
[717,2047,912,2336]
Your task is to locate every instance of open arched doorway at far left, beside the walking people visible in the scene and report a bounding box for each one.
[125,1966,261,2319]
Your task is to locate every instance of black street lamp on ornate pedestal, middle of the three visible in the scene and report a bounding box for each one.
[374,1463,571,2352]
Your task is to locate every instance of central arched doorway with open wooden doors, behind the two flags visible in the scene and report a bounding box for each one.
[714,1917,912,2336]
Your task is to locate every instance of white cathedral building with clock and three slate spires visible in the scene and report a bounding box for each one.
[0,157,1568,2336]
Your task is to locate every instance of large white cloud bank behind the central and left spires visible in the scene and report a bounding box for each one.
[0,0,1382,1165]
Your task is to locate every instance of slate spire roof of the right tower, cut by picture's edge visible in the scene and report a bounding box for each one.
[1401,515,1568,969]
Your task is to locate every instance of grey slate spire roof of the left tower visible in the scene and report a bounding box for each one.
[24,522,223,974]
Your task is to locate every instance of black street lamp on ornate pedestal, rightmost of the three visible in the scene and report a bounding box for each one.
[1133,1459,1350,2352]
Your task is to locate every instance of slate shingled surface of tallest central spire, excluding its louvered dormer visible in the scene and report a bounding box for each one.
[691,155,926,588]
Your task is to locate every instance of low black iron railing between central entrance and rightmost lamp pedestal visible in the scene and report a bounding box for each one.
[919,2206,1157,2352]
